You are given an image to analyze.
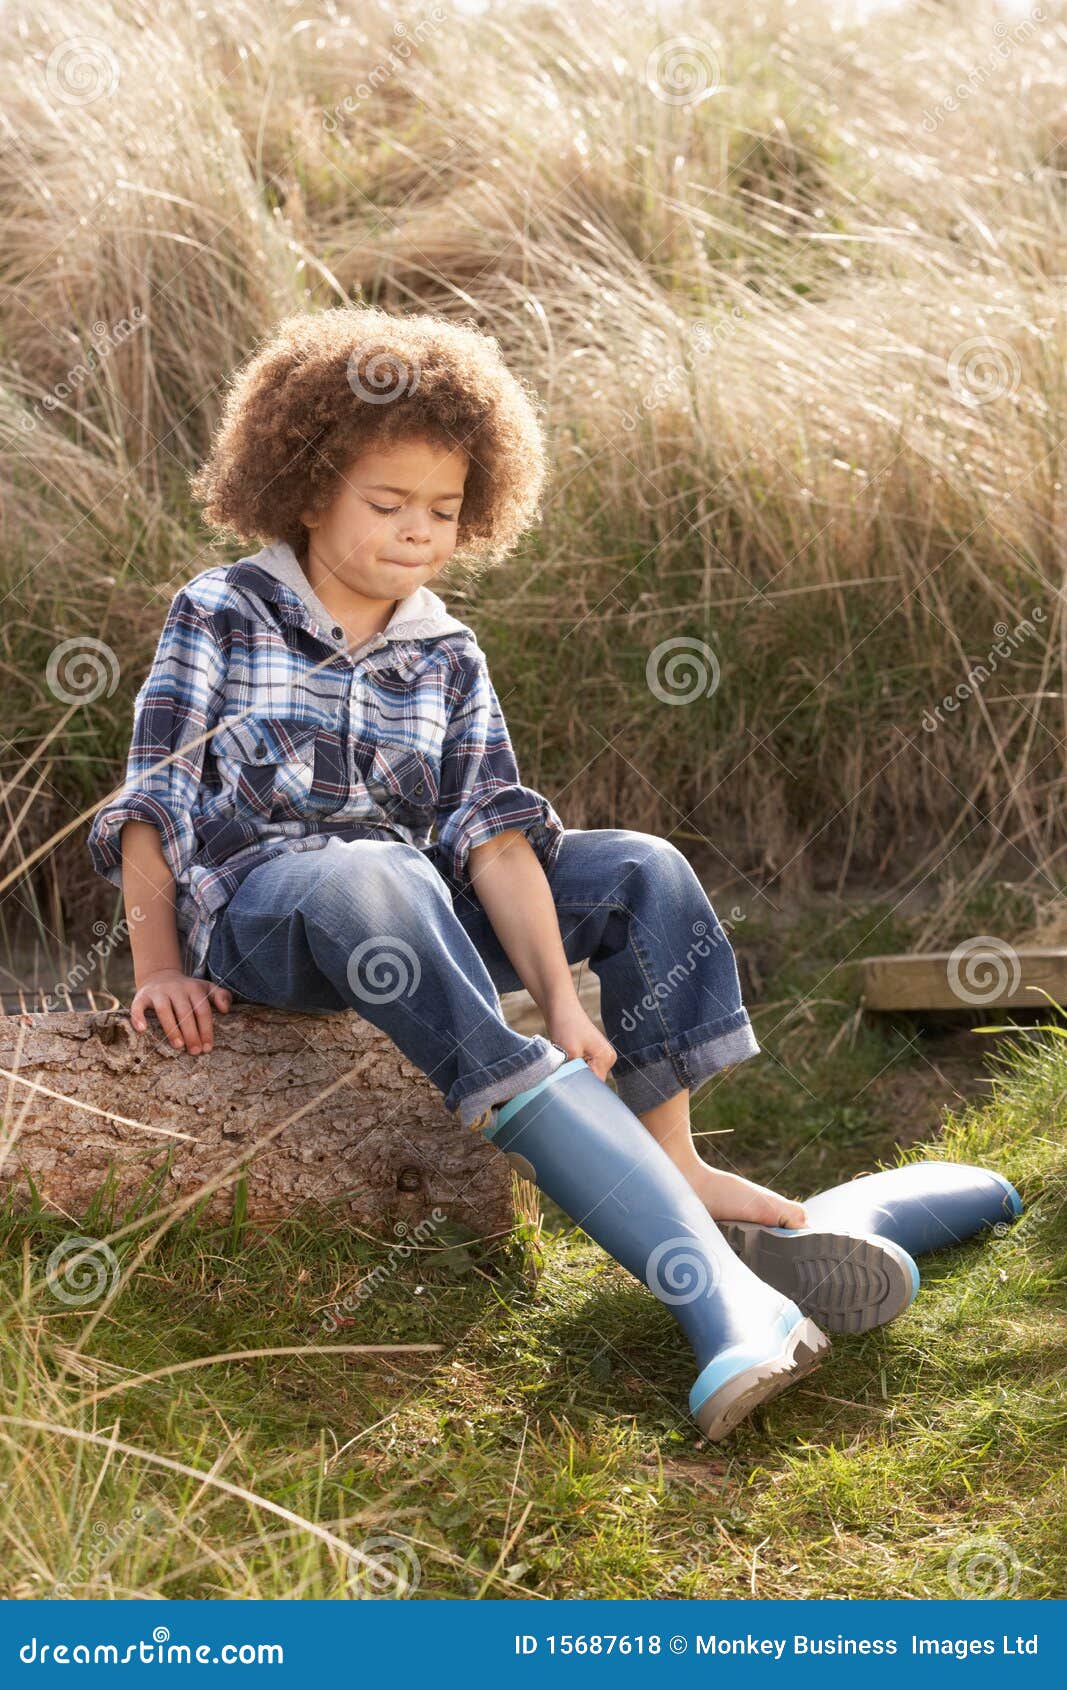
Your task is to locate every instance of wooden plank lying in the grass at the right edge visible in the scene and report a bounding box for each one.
[859,935,1067,1011]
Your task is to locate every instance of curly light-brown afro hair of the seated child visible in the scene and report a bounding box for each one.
[189,306,546,564]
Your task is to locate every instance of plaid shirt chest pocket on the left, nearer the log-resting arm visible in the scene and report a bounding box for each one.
[211,717,345,821]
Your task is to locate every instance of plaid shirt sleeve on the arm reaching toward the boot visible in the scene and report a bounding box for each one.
[436,647,565,880]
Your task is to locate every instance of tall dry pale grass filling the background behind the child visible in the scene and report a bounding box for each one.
[0,0,1067,953]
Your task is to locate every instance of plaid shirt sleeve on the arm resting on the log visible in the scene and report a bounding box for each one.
[86,588,227,887]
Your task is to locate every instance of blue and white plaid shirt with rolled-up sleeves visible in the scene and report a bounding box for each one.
[88,542,563,977]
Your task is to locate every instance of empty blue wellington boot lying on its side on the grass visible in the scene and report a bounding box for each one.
[722,1161,1023,1332]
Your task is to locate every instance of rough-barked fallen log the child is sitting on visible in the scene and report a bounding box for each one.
[0,1002,520,1237]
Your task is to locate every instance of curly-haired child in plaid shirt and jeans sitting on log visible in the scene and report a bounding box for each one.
[88,309,913,1437]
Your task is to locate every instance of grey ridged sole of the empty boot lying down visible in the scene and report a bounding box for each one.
[717,1220,918,1332]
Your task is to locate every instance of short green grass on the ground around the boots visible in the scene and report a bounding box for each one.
[0,911,1067,1599]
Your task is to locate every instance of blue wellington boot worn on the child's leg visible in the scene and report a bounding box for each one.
[480,1056,830,1440]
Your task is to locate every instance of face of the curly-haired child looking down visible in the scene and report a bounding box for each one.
[303,439,470,600]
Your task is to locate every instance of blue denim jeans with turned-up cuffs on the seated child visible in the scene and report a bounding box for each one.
[208,828,759,1127]
